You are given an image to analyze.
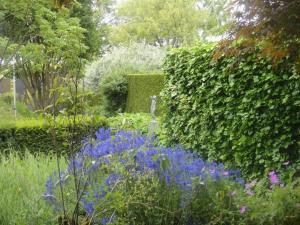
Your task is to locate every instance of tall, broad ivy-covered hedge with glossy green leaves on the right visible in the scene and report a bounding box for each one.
[163,45,300,176]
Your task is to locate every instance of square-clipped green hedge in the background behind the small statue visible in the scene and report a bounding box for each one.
[126,74,165,113]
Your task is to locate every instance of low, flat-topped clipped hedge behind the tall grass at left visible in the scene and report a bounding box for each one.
[0,117,108,154]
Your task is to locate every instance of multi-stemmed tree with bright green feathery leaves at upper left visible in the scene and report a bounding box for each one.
[0,0,86,109]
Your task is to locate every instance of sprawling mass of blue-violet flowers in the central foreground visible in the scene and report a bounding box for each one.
[44,128,243,224]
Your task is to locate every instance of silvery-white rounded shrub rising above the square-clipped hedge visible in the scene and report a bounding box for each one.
[86,43,166,89]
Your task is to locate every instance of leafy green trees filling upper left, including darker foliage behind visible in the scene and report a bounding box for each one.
[0,0,108,109]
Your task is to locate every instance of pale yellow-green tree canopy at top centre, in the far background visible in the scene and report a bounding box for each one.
[110,0,229,47]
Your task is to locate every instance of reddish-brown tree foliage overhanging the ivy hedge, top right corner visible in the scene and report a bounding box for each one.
[223,0,300,64]
